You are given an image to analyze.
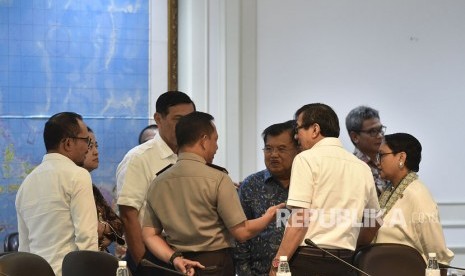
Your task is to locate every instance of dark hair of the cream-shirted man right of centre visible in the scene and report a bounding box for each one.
[294,103,340,138]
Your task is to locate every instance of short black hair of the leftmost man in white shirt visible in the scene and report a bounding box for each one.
[44,112,82,152]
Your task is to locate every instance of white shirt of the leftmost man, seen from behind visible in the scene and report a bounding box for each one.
[16,153,98,276]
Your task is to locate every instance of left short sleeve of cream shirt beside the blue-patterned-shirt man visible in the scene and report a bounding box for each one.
[287,154,314,209]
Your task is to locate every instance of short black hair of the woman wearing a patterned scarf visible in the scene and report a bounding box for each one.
[384,133,422,172]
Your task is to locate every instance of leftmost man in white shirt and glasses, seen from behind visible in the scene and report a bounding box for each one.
[15,112,98,276]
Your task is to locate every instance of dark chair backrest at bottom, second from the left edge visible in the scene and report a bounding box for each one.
[62,250,118,276]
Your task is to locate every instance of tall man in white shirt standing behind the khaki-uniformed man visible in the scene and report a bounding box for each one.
[116,91,195,276]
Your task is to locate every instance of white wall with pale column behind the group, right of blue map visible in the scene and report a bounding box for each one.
[176,0,465,266]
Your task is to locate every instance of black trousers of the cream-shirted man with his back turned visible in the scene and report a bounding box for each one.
[289,246,357,276]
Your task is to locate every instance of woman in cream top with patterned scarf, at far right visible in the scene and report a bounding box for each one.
[374,133,454,264]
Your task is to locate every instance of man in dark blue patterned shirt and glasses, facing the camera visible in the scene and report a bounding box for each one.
[234,120,299,276]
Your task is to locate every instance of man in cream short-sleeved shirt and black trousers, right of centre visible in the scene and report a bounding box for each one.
[270,103,379,276]
